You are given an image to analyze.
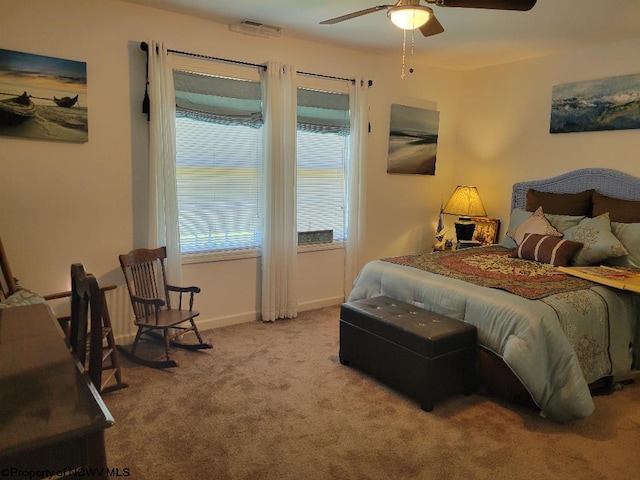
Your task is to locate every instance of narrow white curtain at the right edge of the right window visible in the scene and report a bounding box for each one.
[344,78,369,299]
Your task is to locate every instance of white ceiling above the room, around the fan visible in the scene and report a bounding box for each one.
[125,0,640,70]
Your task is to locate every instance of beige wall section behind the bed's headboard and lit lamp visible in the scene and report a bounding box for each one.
[456,40,640,225]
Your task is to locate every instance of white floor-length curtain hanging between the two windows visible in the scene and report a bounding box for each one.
[262,62,298,321]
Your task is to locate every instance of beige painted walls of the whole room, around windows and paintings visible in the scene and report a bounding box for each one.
[0,0,640,336]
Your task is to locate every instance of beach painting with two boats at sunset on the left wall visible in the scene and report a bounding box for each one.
[0,49,89,143]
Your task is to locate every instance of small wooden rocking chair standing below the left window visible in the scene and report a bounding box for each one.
[119,247,213,368]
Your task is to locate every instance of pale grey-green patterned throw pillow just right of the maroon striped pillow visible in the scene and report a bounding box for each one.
[564,213,629,266]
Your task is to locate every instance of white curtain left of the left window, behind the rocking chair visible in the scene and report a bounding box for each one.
[148,40,182,285]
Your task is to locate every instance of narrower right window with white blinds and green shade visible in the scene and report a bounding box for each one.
[297,83,349,241]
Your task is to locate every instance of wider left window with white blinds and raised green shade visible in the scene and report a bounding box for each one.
[174,70,262,253]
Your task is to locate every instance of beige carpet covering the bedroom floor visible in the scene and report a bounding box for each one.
[104,307,640,480]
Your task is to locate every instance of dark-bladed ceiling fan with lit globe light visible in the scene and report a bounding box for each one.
[320,0,537,37]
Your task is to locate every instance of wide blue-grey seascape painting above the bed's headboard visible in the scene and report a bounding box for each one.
[549,74,640,133]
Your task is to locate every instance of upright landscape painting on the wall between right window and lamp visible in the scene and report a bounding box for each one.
[387,104,439,175]
